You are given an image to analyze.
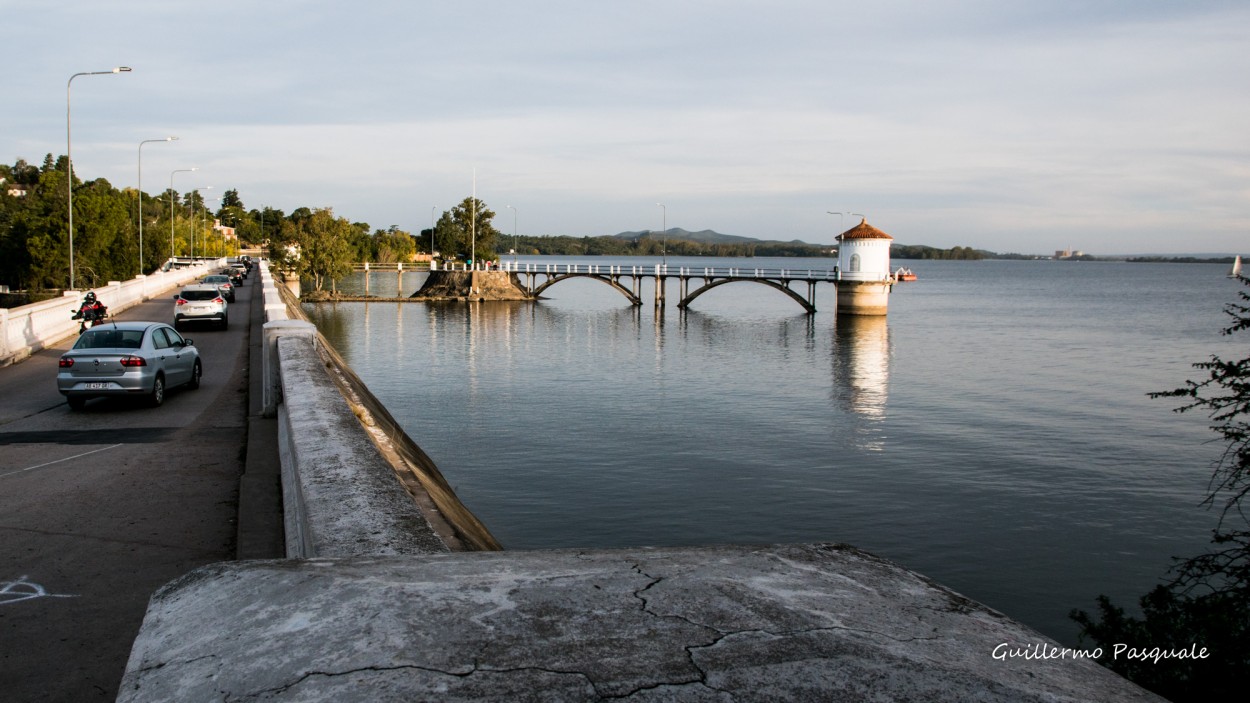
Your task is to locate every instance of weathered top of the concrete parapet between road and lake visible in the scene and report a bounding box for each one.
[275,330,448,558]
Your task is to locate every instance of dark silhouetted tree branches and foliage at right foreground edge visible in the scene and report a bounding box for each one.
[1071,278,1250,702]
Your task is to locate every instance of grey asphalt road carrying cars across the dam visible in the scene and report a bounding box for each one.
[0,276,278,702]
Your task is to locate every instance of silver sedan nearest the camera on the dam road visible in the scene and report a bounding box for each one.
[56,321,204,410]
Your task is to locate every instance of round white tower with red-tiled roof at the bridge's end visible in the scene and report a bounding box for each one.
[838,218,894,315]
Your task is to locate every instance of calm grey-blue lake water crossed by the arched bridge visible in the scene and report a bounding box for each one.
[306,256,1245,644]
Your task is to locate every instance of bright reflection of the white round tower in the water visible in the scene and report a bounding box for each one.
[831,315,890,452]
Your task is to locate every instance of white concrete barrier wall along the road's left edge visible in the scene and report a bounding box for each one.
[0,259,226,367]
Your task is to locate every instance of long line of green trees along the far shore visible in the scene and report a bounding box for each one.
[0,154,1010,294]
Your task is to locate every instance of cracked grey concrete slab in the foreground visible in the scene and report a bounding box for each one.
[119,544,1160,703]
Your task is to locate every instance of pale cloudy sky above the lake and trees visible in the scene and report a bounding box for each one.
[0,0,1250,255]
